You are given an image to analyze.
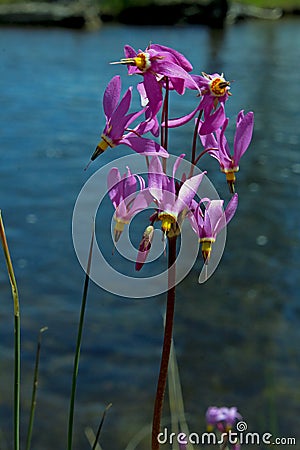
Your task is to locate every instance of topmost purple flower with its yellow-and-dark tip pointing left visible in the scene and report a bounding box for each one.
[112,44,197,117]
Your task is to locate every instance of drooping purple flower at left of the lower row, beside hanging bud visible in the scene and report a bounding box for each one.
[107,167,152,242]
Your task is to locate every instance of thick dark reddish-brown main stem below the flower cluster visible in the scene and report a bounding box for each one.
[151,235,177,450]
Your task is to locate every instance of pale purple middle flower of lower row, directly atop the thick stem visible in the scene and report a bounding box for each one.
[148,155,206,233]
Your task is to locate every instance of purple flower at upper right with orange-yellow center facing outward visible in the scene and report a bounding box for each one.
[168,73,230,135]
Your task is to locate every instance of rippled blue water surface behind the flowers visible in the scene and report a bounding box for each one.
[0,19,300,450]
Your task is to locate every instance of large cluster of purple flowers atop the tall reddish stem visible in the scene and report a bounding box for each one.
[91,44,254,270]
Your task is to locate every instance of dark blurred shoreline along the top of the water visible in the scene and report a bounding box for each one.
[0,0,300,30]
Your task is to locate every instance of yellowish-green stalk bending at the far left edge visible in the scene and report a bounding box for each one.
[0,211,21,450]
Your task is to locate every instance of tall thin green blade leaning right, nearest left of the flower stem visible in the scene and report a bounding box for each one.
[67,230,94,450]
